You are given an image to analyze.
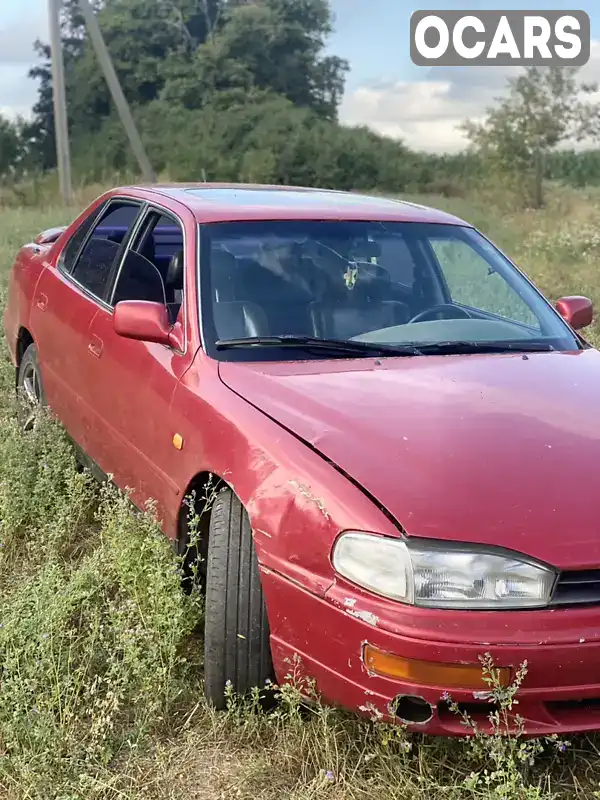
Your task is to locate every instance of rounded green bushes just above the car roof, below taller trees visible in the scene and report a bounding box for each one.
[65,92,476,195]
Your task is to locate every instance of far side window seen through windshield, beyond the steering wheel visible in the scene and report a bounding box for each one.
[430,237,540,329]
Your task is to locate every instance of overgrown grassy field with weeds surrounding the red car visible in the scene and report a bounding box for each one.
[0,183,600,800]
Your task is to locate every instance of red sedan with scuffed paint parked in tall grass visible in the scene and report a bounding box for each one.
[5,184,600,734]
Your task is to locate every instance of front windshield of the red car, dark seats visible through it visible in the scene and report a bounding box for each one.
[202,228,543,350]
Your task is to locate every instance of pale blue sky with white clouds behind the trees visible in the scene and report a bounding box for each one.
[0,0,600,152]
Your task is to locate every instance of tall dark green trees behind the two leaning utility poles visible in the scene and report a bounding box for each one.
[29,0,347,169]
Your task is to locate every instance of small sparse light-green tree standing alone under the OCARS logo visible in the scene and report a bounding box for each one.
[463,67,599,208]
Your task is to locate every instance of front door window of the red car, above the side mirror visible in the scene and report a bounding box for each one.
[113,211,184,321]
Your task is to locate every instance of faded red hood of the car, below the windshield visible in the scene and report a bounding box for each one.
[220,349,600,569]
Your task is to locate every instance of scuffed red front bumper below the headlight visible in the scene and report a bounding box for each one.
[262,570,600,736]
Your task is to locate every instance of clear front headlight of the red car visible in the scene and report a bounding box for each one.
[332,531,556,610]
